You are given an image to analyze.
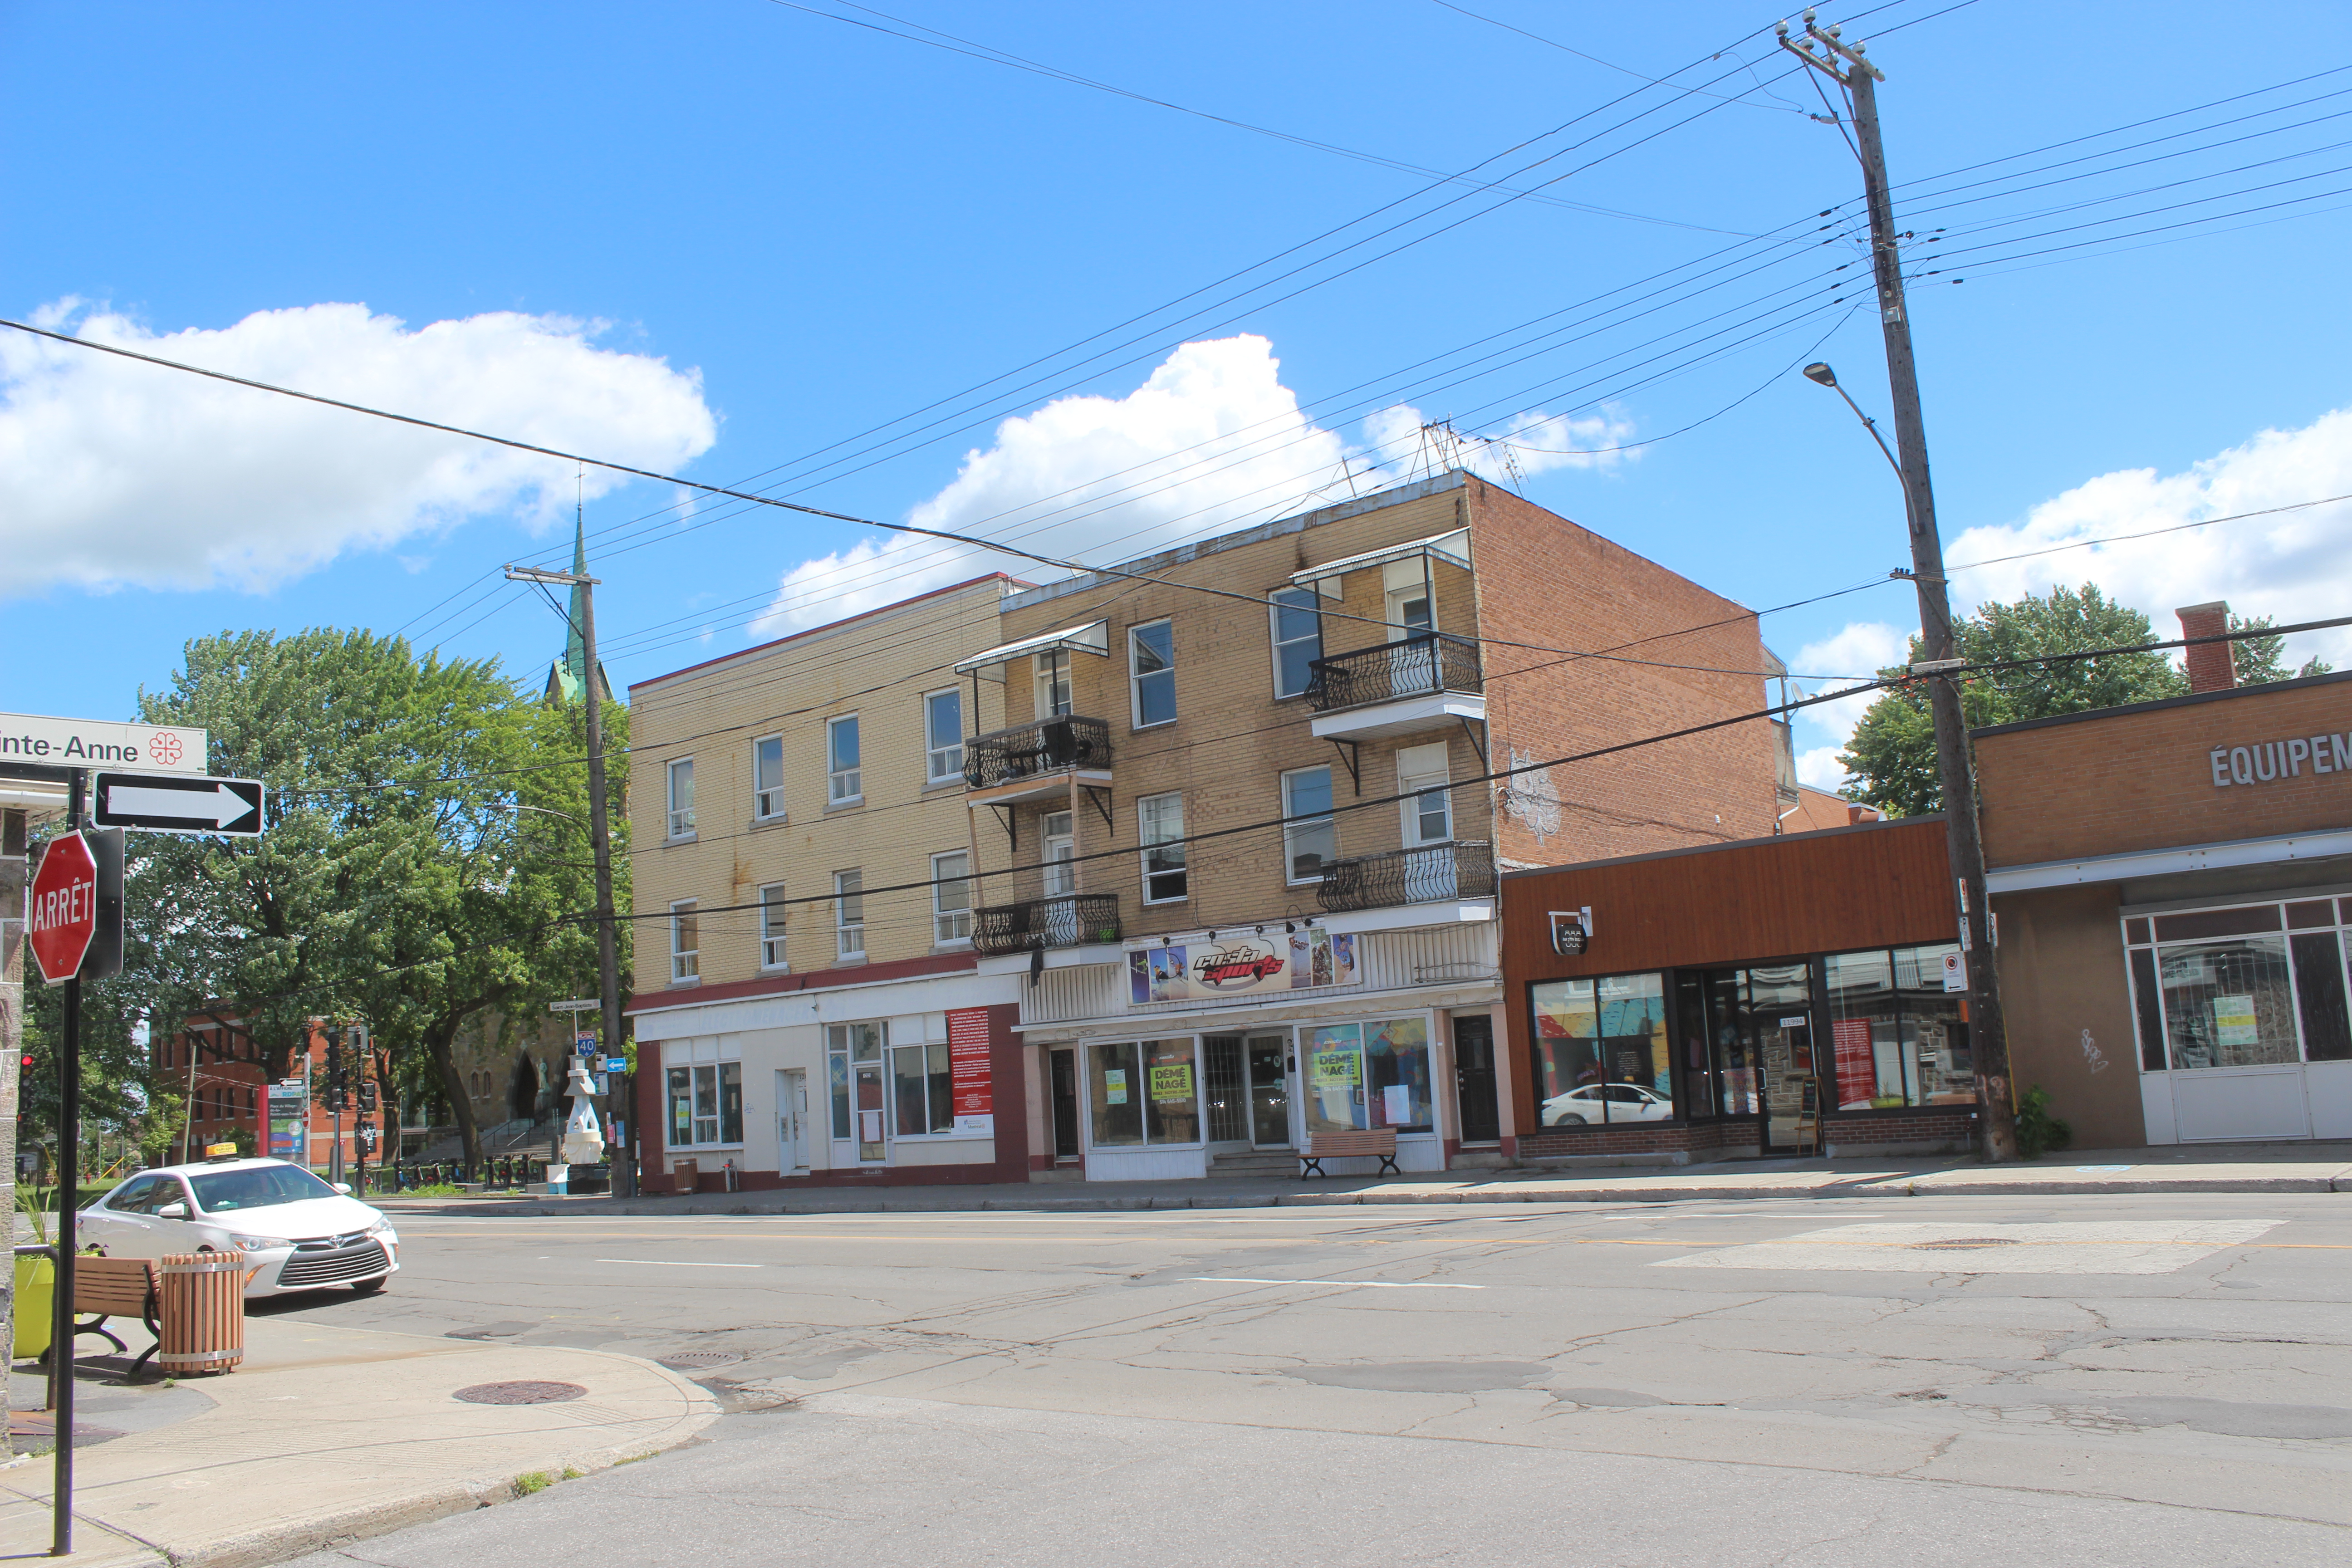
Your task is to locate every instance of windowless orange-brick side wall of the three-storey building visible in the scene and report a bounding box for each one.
[1468,480,1778,865]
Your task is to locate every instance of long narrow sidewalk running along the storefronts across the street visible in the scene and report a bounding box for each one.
[369,1142,2352,1215]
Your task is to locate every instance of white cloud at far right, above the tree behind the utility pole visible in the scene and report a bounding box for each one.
[1792,409,2352,788]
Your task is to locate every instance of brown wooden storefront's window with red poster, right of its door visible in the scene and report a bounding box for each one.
[1825,943,1976,1110]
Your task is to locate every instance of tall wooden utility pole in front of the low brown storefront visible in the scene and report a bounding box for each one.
[1778,10,2018,1161]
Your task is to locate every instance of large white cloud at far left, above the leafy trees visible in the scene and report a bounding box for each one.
[0,301,717,593]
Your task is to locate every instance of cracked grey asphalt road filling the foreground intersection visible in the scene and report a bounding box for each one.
[266,1194,2352,1568]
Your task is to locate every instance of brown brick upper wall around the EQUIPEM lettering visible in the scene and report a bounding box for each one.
[1976,672,2352,865]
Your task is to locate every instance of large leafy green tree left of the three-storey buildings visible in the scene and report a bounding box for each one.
[125,630,626,1171]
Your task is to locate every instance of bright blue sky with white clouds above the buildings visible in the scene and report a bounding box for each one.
[0,0,2352,776]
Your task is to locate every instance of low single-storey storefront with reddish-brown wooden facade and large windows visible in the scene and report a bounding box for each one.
[1503,816,1976,1161]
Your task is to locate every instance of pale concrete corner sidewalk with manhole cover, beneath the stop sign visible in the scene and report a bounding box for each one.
[0,1317,717,1568]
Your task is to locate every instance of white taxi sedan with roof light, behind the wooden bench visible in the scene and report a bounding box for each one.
[73,1159,400,1295]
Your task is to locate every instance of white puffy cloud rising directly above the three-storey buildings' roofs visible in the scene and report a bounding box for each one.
[750,336,1354,639]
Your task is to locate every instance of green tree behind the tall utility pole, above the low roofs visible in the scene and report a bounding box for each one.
[1837,583,2190,816]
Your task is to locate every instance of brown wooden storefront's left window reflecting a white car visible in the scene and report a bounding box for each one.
[1534,973,1675,1126]
